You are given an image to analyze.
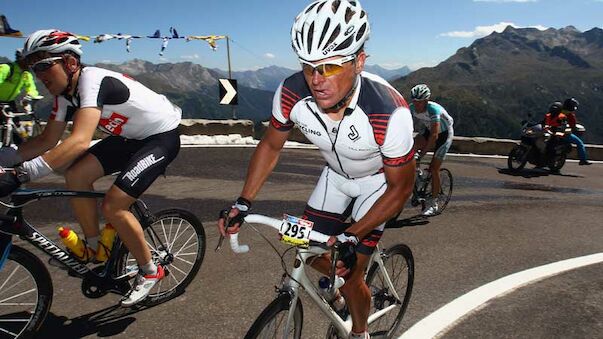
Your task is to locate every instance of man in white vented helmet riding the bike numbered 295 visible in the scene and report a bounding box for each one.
[218,0,414,338]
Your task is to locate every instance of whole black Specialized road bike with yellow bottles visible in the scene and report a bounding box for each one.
[0,189,206,338]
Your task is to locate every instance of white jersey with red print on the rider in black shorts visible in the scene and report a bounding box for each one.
[50,67,182,140]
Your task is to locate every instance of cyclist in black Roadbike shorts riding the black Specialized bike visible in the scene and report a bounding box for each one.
[0,30,181,306]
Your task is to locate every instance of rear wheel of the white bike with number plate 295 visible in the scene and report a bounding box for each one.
[366,244,415,338]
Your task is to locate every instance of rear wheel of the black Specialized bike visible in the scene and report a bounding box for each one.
[116,209,207,306]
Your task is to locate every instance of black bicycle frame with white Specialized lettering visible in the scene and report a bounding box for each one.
[0,190,154,282]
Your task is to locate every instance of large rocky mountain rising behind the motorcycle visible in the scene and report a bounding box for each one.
[393,26,603,143]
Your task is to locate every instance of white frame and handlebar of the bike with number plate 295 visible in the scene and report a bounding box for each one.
[230,214,401,338]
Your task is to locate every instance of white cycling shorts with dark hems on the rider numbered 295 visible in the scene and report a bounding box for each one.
[304,166,387,255]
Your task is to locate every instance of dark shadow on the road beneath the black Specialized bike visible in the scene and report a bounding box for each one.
[36,304,163,339]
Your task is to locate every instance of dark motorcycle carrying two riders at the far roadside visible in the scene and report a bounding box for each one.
[507,120,572,172]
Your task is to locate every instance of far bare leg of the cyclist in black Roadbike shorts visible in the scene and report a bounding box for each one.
[65,153,105,240]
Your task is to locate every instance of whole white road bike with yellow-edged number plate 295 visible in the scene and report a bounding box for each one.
[222,214,414,339]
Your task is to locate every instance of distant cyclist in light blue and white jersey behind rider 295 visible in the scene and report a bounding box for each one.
[410,84,454,216]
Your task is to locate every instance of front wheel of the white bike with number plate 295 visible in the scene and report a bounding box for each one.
[245,293,304,339]
